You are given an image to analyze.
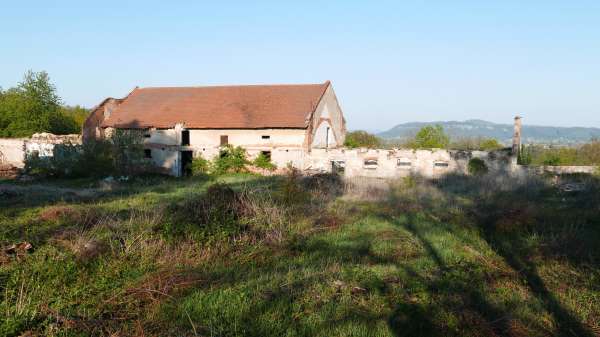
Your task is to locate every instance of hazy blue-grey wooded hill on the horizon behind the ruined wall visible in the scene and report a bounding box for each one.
[378,119,600,144]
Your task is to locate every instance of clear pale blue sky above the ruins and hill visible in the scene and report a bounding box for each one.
[0,0,600,131]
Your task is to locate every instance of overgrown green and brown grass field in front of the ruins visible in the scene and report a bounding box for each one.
[0,175,600,336]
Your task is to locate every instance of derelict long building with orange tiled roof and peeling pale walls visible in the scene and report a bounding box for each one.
[83,81,346,176]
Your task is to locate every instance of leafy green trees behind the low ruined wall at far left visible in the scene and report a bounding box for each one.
[0,71,82,137]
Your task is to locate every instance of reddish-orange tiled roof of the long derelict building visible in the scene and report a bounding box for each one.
[102,81,330,129]
